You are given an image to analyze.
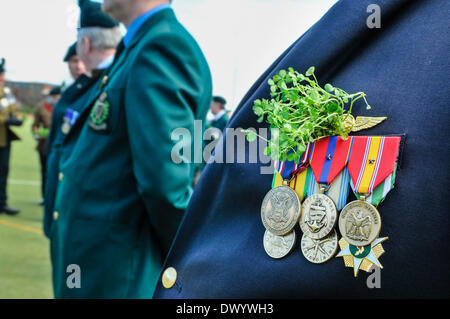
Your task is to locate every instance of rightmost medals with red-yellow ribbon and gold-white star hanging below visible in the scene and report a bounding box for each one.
[337,136,401,277]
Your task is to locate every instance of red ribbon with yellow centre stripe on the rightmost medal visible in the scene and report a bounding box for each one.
[348,136,401,194]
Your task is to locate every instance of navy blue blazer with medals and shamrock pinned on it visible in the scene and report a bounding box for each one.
[154,0,450,298]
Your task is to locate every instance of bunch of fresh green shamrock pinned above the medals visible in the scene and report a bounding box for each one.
[243,66,370,163]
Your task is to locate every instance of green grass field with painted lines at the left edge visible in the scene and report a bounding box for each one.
[0,118,53,299]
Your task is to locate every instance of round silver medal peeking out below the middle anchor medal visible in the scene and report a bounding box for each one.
[300,230,338,264]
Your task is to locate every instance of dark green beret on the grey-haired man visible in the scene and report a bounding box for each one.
[80,1,119,28]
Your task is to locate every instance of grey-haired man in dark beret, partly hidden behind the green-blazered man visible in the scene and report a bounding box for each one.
[44,1,122,298]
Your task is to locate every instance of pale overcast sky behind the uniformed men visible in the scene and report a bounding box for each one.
[0,0,336,109]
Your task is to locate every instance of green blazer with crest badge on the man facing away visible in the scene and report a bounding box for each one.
[51,9,212,298]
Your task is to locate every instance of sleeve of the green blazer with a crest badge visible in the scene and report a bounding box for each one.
[125,34,206,254]
